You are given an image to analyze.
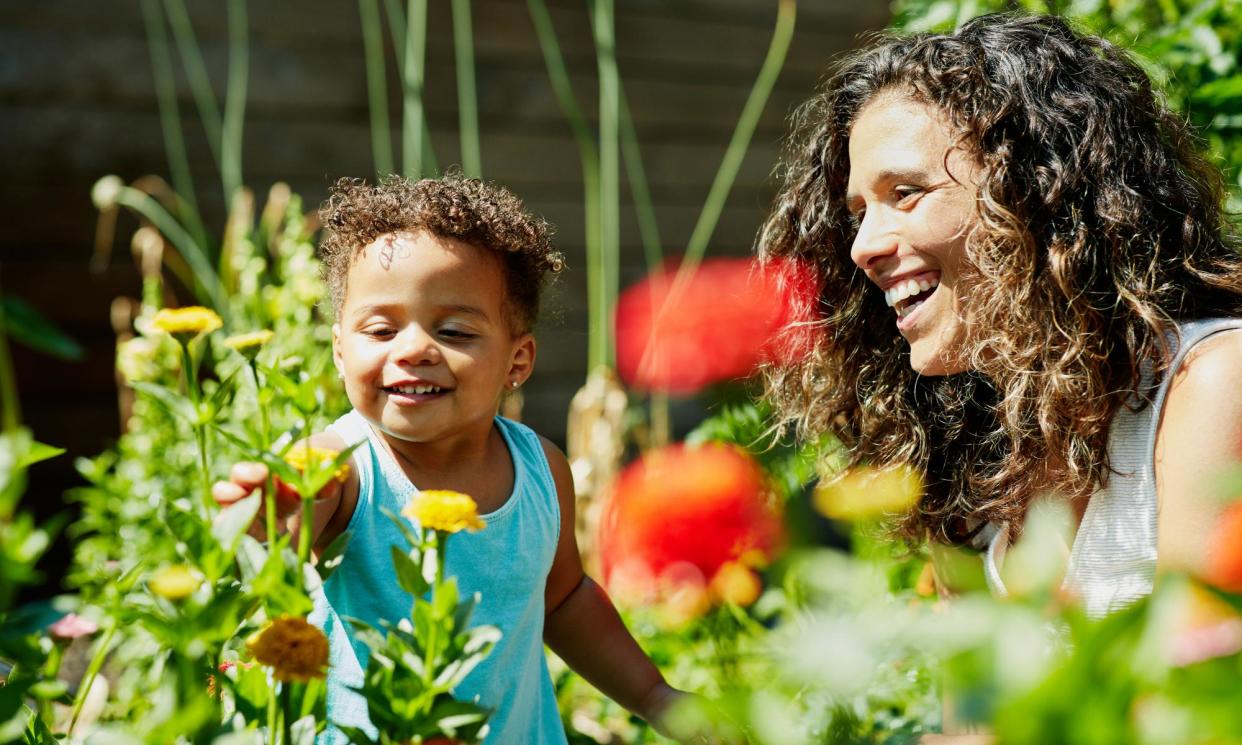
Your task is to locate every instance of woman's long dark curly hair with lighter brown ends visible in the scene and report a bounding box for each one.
[758,14,1242,543]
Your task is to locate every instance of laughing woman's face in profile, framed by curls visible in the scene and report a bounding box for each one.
[846,93,979,375]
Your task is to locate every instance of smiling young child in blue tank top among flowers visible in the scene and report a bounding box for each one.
[215,174,683,745]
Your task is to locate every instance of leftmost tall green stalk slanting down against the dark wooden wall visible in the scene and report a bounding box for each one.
[143,0,207,246]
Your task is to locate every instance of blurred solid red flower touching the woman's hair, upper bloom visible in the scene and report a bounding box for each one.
[616,258,817,394]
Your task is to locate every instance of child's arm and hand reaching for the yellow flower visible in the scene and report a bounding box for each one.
[211,432,358,554]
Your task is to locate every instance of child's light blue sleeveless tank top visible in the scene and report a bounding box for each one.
[311,411,565,745]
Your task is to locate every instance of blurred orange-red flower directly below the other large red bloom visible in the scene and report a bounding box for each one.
[599,445,781,601]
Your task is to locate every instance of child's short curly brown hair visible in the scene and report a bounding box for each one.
[319,170,565,333]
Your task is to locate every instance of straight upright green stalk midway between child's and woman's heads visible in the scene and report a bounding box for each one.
[590,0,621,365]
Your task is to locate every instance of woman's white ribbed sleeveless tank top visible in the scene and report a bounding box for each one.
[984,318,1242,618]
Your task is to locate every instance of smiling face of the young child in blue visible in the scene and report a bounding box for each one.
[332,232,535,443]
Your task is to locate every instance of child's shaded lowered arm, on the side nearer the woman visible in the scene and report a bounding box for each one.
[544,440,686,734]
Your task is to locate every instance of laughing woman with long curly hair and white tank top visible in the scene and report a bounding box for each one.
[759,15,1242,615]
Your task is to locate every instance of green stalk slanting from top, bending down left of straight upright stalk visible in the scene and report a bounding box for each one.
[527,0,609,370]
